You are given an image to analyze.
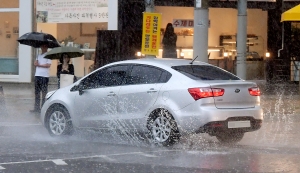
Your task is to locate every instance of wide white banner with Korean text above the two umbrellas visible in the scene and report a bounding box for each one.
[36,0,108,23]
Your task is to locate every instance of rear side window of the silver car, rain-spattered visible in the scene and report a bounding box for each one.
[126,65,163,85]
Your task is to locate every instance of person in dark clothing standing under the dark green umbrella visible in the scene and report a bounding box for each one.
[56,54,75,88]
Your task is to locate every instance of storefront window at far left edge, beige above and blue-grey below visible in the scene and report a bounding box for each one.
[0,11,19,75]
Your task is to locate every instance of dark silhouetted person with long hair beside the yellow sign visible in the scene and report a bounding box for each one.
[162,23,177,58]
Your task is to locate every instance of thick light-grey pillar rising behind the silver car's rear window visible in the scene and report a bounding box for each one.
[193,0,209,62]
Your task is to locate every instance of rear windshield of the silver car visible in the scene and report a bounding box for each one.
[172,65,240,80]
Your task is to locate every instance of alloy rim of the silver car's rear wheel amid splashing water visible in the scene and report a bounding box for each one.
[152,117,171,142]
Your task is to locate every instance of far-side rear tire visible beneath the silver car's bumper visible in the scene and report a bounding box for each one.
[216,132,244,144]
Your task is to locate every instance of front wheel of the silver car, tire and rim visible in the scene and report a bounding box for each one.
[46,106,74,136]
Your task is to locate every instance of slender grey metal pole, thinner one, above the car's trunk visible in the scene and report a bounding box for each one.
[236,0,247,80]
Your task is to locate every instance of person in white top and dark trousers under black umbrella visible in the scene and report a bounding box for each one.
[30,45,51,112]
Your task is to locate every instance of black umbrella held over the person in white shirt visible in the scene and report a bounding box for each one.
[18,32,60,48]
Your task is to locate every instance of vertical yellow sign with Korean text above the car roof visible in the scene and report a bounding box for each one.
[141,13,161,55]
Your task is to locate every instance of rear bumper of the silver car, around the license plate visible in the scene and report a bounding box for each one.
[175,106,263,133]
